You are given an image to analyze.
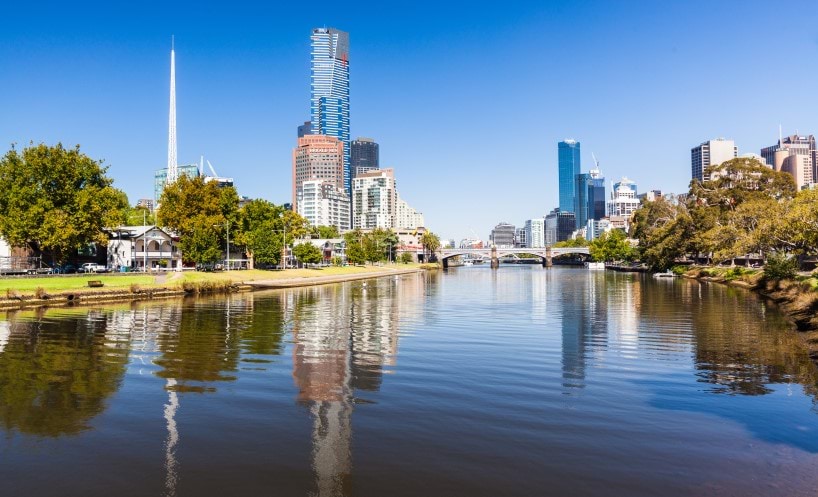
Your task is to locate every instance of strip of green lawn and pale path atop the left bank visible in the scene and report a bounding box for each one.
[0,264,420,302]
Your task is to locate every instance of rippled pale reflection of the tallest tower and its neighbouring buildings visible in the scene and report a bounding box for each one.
[292,276,427,497]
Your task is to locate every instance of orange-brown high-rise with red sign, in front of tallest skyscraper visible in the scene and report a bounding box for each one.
[292,135,346,212]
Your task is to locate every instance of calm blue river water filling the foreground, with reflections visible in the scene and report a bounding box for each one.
[0,266,818,497]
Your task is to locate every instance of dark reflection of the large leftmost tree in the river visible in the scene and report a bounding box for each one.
[0,319,128,437]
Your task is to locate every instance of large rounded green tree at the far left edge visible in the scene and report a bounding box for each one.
[0,143,128,262]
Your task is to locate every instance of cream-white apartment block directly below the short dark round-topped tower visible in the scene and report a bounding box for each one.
[352,168,398,229]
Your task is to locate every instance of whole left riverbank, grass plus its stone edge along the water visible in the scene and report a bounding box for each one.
[0,264,425,309]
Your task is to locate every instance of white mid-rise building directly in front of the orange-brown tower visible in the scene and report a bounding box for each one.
[296,179,350,232]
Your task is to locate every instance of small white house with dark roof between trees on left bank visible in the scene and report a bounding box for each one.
[107,226,182,271]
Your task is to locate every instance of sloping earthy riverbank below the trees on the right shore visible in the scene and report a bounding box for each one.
[682,267,818,364]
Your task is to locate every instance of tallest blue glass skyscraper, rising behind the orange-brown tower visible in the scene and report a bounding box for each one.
[310,28,352,195]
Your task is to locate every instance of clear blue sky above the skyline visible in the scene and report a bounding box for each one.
[0,1,818,240]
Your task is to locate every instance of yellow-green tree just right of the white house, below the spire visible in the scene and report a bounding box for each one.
[156,175,241,263]
